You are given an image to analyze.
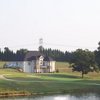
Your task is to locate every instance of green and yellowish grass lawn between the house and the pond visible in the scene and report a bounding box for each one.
[0,62,100,94]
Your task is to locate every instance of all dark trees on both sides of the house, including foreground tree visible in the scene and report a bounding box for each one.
[0,42,100,77]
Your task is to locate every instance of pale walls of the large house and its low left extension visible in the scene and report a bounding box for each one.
[6,61,55,73]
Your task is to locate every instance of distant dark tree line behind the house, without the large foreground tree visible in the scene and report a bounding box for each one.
[0,42,100,65]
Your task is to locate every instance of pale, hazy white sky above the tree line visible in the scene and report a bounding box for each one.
[0,0,100,51]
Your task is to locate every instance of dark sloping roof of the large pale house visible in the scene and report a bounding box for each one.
[24,51,54,61]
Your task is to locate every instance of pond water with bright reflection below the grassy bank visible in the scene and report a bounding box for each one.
[0,93,100,100]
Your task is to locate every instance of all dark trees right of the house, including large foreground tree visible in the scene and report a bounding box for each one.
[42,42,100,78]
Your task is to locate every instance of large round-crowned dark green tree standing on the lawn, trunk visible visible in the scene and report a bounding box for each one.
[72,49,97,78]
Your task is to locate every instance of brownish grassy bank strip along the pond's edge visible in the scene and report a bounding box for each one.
[0,89,99,98]
